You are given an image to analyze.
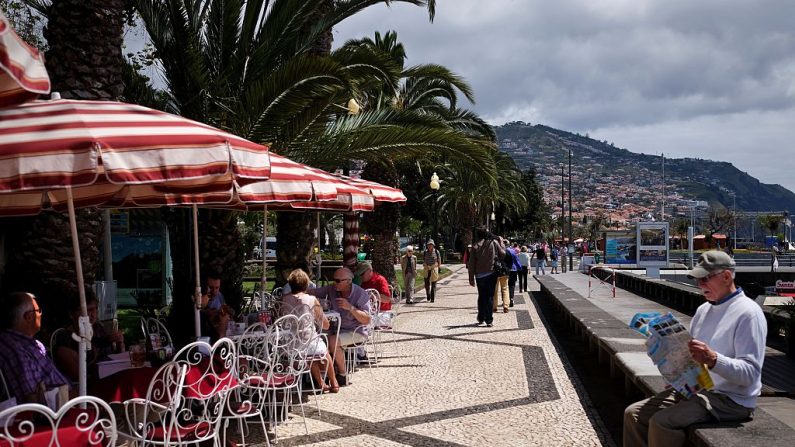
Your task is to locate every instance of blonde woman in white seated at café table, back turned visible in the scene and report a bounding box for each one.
[280,269,340,393]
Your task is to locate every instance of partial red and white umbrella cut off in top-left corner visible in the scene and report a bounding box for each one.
[0,10,50,107]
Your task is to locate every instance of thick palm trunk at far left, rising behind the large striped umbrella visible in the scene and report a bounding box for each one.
[4,0,124,326]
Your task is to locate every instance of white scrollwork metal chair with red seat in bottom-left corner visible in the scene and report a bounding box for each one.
[0,396,118,446]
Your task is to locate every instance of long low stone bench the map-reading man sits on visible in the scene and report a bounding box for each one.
[536,276,795,447]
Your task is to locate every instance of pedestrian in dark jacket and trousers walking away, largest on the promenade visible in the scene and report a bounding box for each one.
[467,227,505,327]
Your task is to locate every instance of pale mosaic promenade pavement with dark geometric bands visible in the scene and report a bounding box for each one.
[255,266,611,447]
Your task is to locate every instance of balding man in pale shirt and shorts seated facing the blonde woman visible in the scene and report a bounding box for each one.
[307,267,371,386]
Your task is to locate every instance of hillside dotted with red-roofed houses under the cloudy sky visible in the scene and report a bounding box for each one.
[495,122,795,211]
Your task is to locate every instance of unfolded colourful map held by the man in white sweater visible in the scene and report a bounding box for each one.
[629,312,713,397]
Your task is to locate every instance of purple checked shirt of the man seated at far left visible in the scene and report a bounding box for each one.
[0,329,69,402]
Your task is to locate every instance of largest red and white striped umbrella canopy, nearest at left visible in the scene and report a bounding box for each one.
[0,100,270,215]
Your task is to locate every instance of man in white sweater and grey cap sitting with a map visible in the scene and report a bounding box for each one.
[624,250,767,447]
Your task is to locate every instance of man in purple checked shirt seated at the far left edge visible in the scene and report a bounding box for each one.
[0,292,68,405]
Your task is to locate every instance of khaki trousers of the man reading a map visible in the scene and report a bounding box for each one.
[624,389,753,447]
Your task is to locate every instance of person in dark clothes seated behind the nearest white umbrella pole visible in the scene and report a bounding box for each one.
[52,289,124,382]
